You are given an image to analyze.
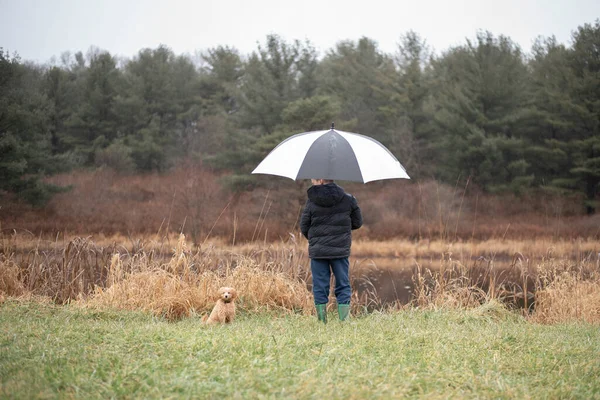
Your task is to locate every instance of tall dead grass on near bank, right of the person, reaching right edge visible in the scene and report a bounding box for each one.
[413,256,600,324]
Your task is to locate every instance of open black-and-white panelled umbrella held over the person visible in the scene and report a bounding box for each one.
[252,124,410,183]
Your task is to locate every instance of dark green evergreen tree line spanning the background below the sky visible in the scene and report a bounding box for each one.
[0,20,600,213]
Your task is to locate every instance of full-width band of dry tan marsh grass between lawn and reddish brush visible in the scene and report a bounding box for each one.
[0,233,600,323]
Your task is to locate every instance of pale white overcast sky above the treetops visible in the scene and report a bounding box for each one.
[0,0,600,62]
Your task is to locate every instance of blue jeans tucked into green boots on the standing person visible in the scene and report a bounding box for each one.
[310,257,352,304]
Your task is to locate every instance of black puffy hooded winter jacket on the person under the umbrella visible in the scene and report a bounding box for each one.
[300,183,362,258]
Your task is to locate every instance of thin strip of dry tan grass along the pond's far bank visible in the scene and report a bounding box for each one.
[5,231,600,264]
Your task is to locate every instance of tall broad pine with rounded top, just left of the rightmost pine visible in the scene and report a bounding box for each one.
[429,32,533,191]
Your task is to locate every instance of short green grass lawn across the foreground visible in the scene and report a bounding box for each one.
[0,300,600,399]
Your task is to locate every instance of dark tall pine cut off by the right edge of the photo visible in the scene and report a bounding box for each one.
[528,21,600,214]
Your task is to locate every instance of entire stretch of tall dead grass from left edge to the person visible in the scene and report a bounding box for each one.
[0,234,312,319]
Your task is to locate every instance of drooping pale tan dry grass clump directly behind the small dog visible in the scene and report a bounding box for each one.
[86,235,312,319]
